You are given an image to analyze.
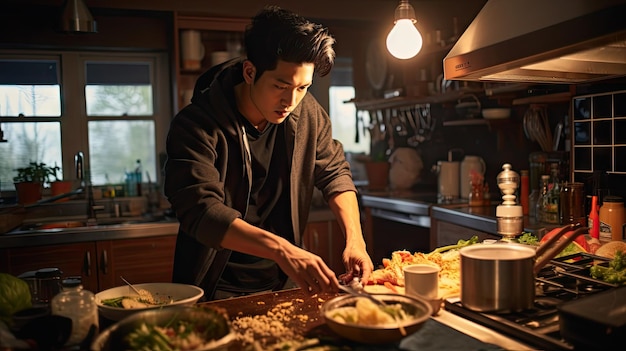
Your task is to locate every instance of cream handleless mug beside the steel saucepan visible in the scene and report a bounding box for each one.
[403,264,440,300]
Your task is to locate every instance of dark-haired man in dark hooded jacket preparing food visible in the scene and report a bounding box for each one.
[165,7,373,299]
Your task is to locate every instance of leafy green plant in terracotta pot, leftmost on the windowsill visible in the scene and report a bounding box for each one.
[13,162,55,205]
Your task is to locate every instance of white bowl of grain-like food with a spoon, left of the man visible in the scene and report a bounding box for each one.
[96,283,204,321]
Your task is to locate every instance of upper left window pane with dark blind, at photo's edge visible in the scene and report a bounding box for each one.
[0,60,61,117]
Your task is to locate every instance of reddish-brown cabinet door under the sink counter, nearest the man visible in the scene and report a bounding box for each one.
[96,235,176,291]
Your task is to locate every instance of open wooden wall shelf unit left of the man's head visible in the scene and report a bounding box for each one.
[174,13,250,111]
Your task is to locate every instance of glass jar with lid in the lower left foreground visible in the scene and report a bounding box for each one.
[50,279,98,346]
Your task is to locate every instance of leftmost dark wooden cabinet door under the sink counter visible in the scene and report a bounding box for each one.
[0,242,98,292]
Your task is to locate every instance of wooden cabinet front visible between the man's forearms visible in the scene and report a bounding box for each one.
[303,220,346,275]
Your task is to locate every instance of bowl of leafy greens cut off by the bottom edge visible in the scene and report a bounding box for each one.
[91,305,235,351]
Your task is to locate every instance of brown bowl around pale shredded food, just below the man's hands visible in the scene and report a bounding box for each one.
[321,294,432,344]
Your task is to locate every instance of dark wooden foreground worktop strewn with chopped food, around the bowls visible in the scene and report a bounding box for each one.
[196,289,531,351]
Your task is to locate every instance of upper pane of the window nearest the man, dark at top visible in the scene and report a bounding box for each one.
[85,62,153,116]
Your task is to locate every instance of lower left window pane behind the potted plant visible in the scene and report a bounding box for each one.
[0,122,63,190]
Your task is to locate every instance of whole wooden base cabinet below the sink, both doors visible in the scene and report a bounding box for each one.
[0,235,176,292]
